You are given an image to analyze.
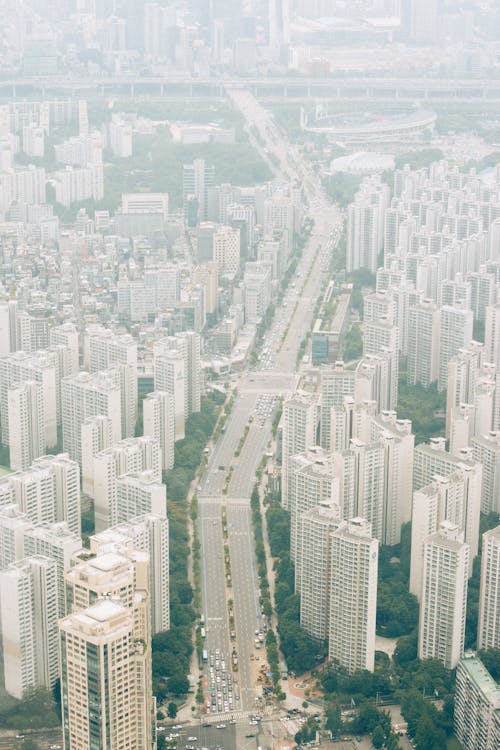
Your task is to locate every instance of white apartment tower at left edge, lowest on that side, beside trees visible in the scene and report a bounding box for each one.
[0,555,59,700]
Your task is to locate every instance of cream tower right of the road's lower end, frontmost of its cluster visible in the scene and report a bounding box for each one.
[328,518,379,673]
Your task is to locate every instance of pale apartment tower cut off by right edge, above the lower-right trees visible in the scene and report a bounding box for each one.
[477,526,500,651]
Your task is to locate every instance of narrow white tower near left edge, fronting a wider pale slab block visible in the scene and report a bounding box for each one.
[7,380,45,471]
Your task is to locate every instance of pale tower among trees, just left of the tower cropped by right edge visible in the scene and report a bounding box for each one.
[418,521,470,669]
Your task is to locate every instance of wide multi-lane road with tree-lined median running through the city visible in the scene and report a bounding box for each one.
[198,85,341,747]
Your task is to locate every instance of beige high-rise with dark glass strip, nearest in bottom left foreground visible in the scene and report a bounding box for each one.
[59,594,153,750]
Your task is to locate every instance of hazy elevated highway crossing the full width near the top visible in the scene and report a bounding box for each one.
[0,75,500,108]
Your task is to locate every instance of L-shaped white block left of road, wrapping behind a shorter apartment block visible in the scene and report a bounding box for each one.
[94,435,162,531]
